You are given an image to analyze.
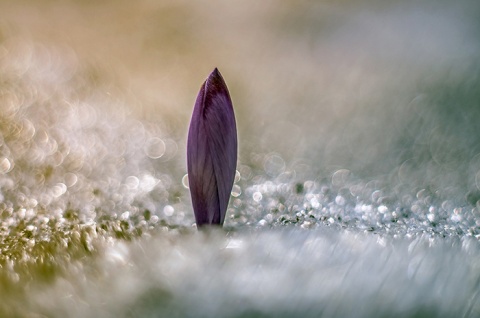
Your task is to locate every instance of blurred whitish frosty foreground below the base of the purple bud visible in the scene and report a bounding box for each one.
[35,227,480,317]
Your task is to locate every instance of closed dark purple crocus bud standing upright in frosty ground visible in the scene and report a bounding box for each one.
[187,68,237,227]
